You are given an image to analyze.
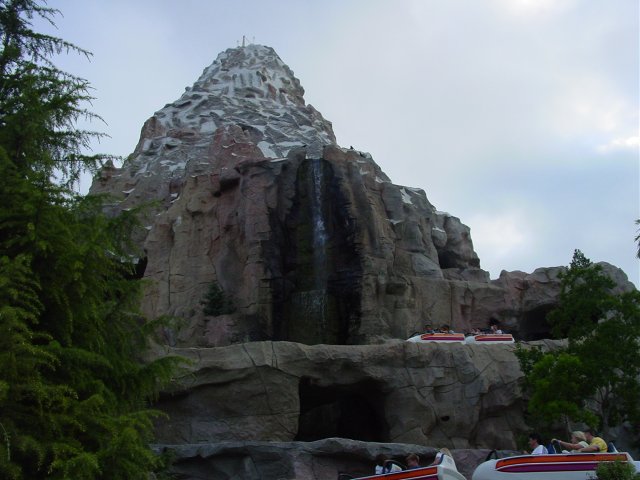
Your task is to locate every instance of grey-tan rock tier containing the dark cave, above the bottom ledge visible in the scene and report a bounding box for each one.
[152,341,525,449]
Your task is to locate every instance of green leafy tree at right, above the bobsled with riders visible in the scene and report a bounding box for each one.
[517,250,640,435]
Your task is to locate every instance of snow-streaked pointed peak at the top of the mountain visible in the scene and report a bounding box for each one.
[122,44,336,184]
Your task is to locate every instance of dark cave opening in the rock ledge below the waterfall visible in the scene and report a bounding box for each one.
[295,378,389,442]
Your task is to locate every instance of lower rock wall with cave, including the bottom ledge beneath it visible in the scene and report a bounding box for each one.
[156,341,526,479]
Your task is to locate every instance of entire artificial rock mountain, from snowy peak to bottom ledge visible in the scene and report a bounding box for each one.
[91,45,633,478]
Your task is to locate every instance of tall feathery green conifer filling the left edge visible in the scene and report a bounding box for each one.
[0,0,180,479]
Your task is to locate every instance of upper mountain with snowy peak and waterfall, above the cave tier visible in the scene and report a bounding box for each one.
[92,45,631,347]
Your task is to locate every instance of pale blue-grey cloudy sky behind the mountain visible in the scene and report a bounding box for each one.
[40,0,640,285]
